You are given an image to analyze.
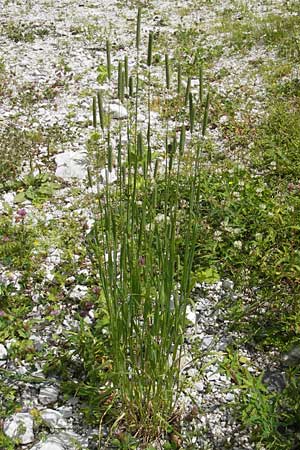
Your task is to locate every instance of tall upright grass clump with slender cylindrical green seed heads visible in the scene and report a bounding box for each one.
[82,10,208,441]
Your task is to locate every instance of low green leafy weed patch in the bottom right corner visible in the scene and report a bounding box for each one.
[223,352,300,450]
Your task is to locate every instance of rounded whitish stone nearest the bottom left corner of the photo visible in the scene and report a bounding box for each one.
[3,413,34,445]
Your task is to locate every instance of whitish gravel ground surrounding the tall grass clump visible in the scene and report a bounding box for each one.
[0,0,292,450]
